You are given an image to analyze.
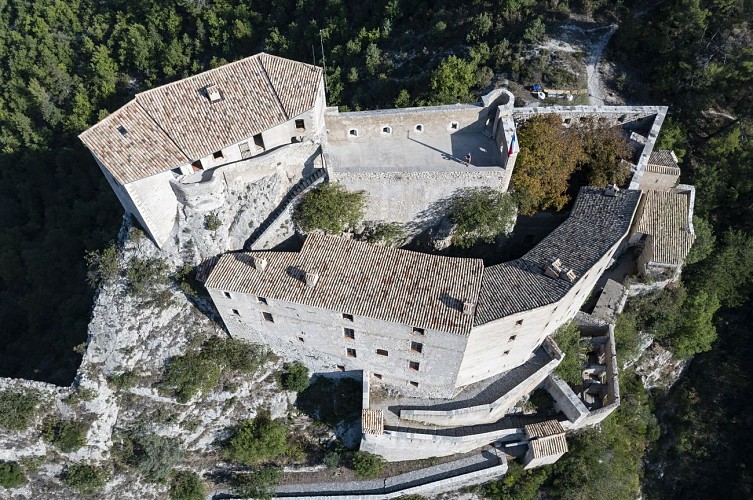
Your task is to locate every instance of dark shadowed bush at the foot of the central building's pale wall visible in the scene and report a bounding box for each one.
[296,377,362,428]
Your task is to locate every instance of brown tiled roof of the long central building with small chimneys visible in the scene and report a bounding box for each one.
[206,234,483,335]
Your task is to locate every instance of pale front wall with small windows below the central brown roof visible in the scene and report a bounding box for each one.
[209,289,467,397]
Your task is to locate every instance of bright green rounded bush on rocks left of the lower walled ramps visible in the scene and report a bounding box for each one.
[225,412,290,465]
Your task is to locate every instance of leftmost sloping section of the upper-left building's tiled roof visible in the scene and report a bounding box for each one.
[79,101,189,184]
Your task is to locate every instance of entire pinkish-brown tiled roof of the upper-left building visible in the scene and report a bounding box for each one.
[80,53,322,184]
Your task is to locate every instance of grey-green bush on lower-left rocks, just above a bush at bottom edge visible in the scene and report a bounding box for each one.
[117,433,190,483]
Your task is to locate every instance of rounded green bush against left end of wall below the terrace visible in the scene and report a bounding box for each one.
[293,182,366,235]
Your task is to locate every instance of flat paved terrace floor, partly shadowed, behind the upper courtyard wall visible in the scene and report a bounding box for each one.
[327,131,500,172]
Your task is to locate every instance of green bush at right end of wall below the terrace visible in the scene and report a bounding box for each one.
[450,187,516,248]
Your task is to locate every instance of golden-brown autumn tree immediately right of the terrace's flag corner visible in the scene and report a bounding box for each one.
[510,115,584,215]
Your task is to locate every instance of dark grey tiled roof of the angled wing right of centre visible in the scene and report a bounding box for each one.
[476,187,640,325]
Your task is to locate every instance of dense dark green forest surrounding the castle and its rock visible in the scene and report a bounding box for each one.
[0,0,753,498]
